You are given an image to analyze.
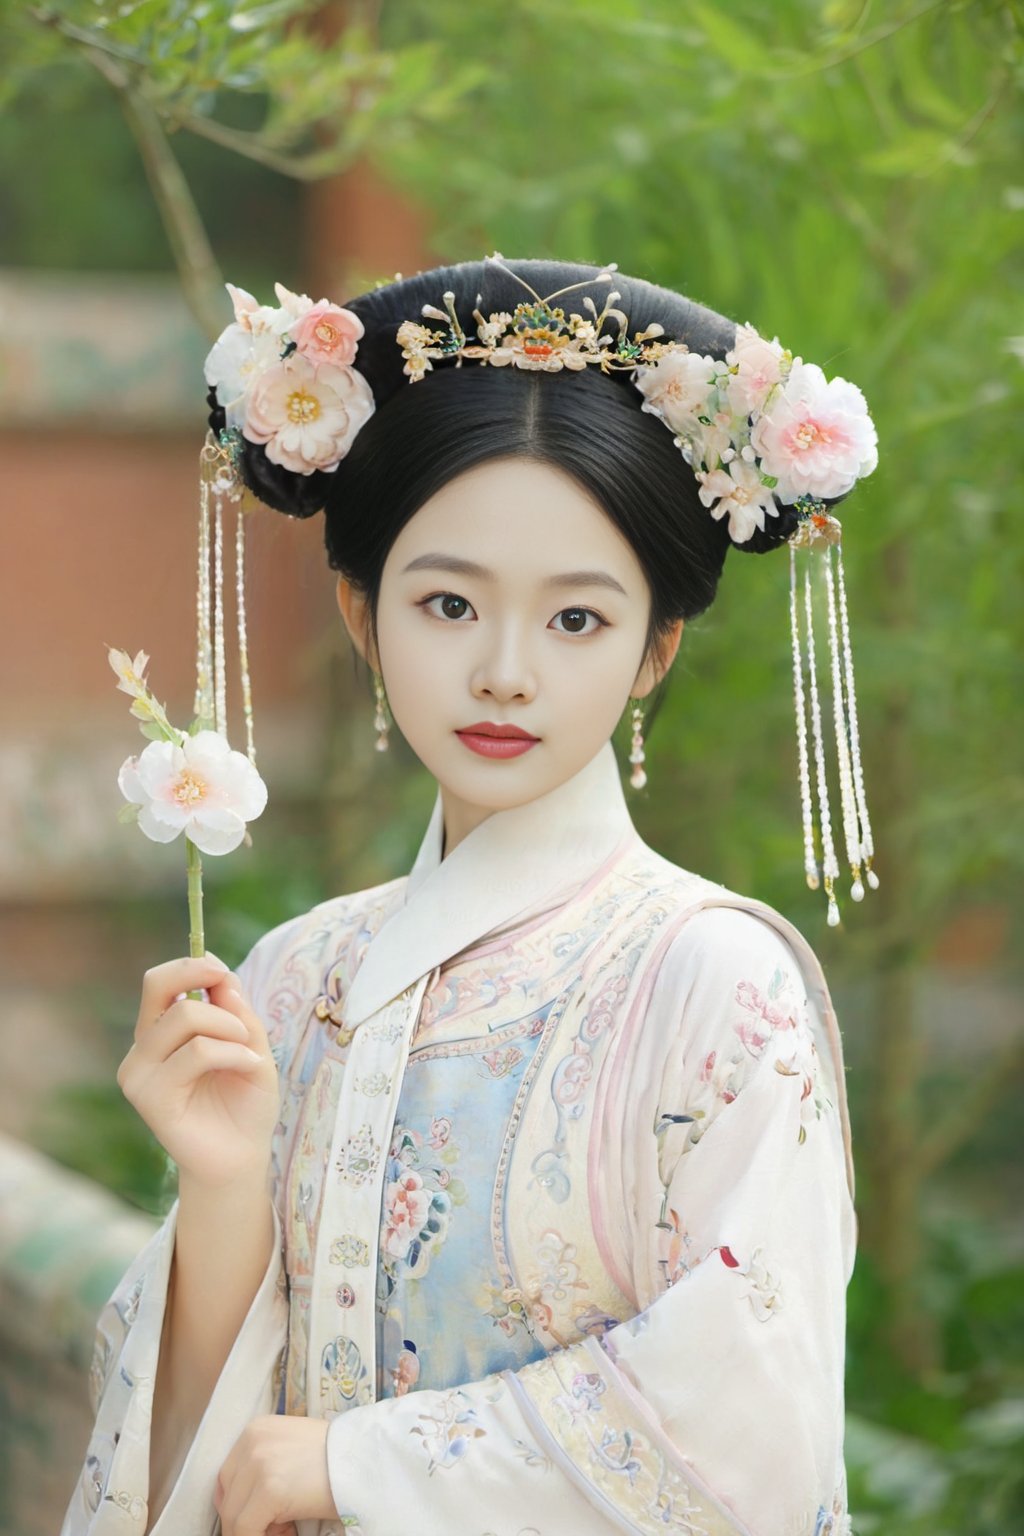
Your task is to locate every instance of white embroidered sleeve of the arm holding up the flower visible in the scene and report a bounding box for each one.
[61,919,308,1536]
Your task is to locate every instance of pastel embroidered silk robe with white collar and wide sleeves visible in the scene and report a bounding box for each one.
[63,743,857,1536]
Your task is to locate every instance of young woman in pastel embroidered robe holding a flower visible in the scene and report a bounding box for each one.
[64,260,869,1536]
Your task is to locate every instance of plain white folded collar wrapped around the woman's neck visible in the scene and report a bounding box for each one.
[344,740,639,1029]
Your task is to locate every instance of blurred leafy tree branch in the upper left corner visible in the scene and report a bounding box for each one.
[11,0,484,339]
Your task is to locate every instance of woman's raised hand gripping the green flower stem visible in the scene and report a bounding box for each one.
[117,954,279,1187]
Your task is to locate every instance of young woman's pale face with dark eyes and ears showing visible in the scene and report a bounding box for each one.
[338,458,682,856]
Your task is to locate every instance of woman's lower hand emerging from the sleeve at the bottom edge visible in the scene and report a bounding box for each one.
[213,1413,338,1536]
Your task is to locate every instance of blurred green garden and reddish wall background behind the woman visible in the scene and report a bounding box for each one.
[0,0,1024,1536]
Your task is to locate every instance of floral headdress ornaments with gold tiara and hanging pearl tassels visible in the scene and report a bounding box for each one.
[197,252,878,926]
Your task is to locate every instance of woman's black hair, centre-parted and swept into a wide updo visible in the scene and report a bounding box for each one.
[209,258,841,718]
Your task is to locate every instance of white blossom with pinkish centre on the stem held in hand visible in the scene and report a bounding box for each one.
[117,731,267,854]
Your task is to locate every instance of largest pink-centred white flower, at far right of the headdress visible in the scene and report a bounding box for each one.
[751,359,878,504]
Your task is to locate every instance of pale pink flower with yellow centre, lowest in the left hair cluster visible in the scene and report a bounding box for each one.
[243,352,375,475]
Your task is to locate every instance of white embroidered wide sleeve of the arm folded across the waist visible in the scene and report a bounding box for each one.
[327,908,855,1536]
